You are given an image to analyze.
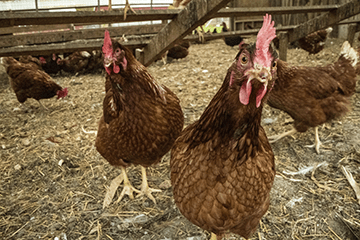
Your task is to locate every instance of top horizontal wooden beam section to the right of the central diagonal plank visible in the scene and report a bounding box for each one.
[213,5,339,18]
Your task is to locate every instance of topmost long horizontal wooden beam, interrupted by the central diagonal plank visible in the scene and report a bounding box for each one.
[0,5,339,27]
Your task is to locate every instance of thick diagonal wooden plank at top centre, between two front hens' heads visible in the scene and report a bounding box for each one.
[143,0,230,66]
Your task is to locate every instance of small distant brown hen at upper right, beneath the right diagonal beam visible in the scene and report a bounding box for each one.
[298,27,333,54]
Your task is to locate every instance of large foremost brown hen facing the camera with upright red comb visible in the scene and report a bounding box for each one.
[170,15,277,239]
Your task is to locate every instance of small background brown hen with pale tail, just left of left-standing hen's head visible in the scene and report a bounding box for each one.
[58,51,91,73]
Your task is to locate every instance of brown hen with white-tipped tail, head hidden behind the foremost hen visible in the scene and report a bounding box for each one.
[268,42,358,154]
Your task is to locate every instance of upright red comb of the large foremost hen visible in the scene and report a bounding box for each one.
[255,14,276,67]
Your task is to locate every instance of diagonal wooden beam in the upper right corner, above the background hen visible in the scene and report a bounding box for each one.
[289,0,360,42]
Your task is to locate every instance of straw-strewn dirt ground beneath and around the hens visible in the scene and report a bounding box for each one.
[0,36,360,240]
